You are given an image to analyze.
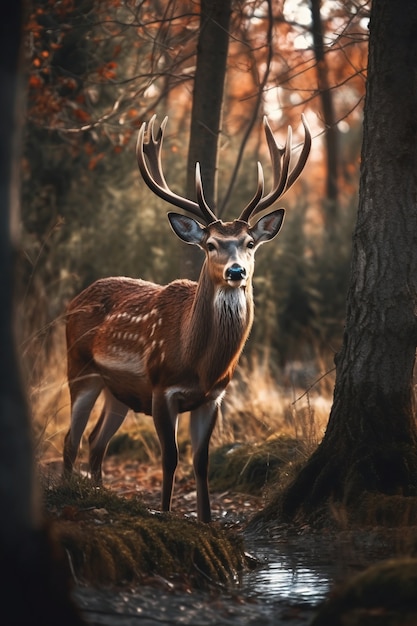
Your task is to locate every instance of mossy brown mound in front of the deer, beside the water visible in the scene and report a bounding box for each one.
[46,479,246,587]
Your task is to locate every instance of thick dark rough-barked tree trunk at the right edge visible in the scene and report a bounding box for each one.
[282,0,417,519]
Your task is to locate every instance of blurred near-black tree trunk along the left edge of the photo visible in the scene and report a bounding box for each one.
[0,2,35,541]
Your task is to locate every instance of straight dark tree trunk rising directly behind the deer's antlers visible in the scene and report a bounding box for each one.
[183,0,231,279]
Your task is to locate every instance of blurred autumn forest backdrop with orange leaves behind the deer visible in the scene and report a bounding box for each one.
[20,0,368,386]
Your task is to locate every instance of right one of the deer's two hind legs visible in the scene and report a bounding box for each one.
[88,388,128,485]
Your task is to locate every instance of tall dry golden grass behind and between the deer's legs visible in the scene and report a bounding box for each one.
[28,316,333,478]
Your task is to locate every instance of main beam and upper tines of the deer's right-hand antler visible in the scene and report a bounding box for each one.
[240,115,311,221]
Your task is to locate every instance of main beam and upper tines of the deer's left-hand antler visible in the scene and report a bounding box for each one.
[136,115,217,224]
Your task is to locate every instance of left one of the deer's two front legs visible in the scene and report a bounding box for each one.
[152,391,178,511]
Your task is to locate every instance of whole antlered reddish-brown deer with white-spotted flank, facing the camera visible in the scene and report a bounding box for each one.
[63,115,311,523]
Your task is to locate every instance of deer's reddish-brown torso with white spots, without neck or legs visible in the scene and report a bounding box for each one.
[66,277,202,412]
